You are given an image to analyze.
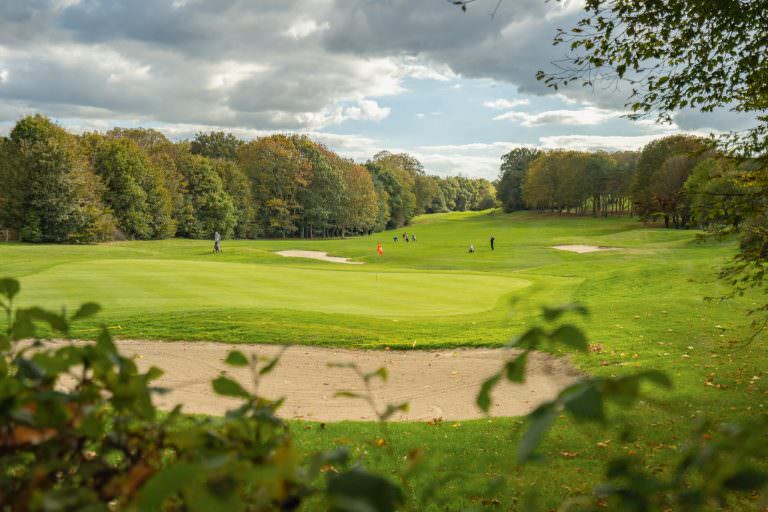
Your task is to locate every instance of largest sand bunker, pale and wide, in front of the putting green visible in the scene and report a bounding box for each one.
[45,340,579,421]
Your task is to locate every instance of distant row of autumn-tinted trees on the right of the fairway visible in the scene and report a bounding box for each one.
[495,135,749,227]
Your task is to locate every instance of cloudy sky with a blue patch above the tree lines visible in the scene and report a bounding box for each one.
[0,0,753,179]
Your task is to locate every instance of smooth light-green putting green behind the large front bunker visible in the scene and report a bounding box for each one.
[19,259,531,317]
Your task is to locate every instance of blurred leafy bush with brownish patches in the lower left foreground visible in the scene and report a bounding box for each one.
[0,278,396,512]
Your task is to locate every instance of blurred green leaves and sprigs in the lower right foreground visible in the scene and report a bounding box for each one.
[476,305,768,511]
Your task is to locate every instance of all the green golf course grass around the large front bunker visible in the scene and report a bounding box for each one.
[0,212,768,509]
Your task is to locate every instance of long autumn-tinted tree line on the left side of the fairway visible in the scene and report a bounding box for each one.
[0,115,496,243]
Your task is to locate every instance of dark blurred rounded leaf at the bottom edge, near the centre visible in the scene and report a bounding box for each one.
[326,468,404,512]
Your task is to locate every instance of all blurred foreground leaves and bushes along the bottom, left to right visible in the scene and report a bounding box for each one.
[0,279,768,512]
